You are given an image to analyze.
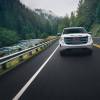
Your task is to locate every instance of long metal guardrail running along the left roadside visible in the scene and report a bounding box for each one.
[0,38,57,67]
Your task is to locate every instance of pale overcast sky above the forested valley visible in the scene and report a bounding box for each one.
[20,0,79,16]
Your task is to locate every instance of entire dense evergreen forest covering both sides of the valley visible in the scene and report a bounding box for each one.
[0,0,100,47]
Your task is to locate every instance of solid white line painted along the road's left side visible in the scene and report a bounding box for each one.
[12,45,59,100]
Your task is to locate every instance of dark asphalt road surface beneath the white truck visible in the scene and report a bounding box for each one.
[0,38,100,100]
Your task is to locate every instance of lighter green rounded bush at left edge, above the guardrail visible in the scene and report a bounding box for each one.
[0,28,19,47]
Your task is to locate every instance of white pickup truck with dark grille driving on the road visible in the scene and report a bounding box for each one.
[59,27,93,55]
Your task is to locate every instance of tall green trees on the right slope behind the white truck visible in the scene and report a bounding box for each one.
[59,0,100,36]
